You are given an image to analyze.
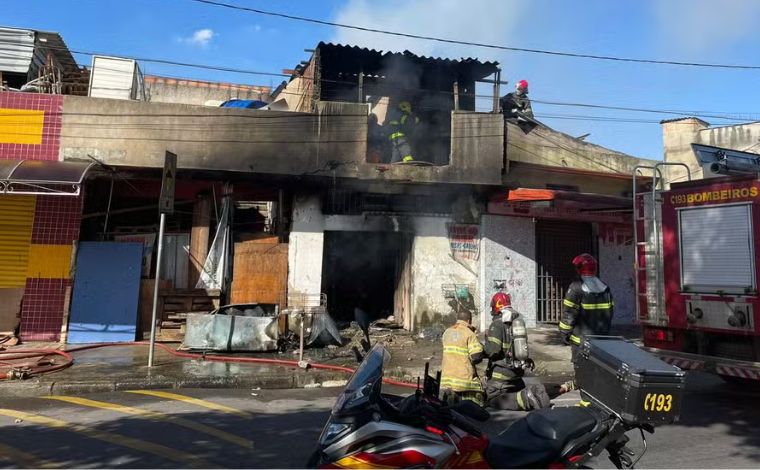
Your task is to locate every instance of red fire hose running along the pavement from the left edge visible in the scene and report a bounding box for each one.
[0,339,417,388]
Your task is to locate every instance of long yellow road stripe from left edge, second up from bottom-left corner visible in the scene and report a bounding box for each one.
[0,408,211,468]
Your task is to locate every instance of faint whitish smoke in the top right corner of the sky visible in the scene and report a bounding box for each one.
[652,0,760,55]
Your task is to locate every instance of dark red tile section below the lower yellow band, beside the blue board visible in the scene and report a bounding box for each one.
[20,279,71,341]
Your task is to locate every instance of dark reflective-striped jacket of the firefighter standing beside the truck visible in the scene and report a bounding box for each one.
[559,276,614,345]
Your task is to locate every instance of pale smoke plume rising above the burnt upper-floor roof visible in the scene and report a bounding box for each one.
[333,0,525,59]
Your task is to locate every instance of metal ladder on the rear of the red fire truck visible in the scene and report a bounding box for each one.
[633,162,691,325]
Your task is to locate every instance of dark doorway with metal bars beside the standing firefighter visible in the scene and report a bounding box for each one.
[536,220,595,323]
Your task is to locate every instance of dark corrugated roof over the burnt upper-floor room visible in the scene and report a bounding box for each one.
[317,42,499,80]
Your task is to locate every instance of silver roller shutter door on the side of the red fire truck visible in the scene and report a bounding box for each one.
[679,204,756,294]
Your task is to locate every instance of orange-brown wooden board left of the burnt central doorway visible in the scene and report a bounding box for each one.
[230,240,288,308]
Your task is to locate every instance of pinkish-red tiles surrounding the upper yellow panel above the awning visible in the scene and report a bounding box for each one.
[0,91,63,160]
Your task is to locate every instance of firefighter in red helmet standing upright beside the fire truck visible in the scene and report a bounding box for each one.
[559,253,614,393]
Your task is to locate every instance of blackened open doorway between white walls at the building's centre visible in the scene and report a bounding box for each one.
[322,231,411,324]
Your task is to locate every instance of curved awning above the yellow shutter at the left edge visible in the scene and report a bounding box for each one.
[0,160,95,196]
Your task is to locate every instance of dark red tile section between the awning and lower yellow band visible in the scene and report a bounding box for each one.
[32,195,82,245]
